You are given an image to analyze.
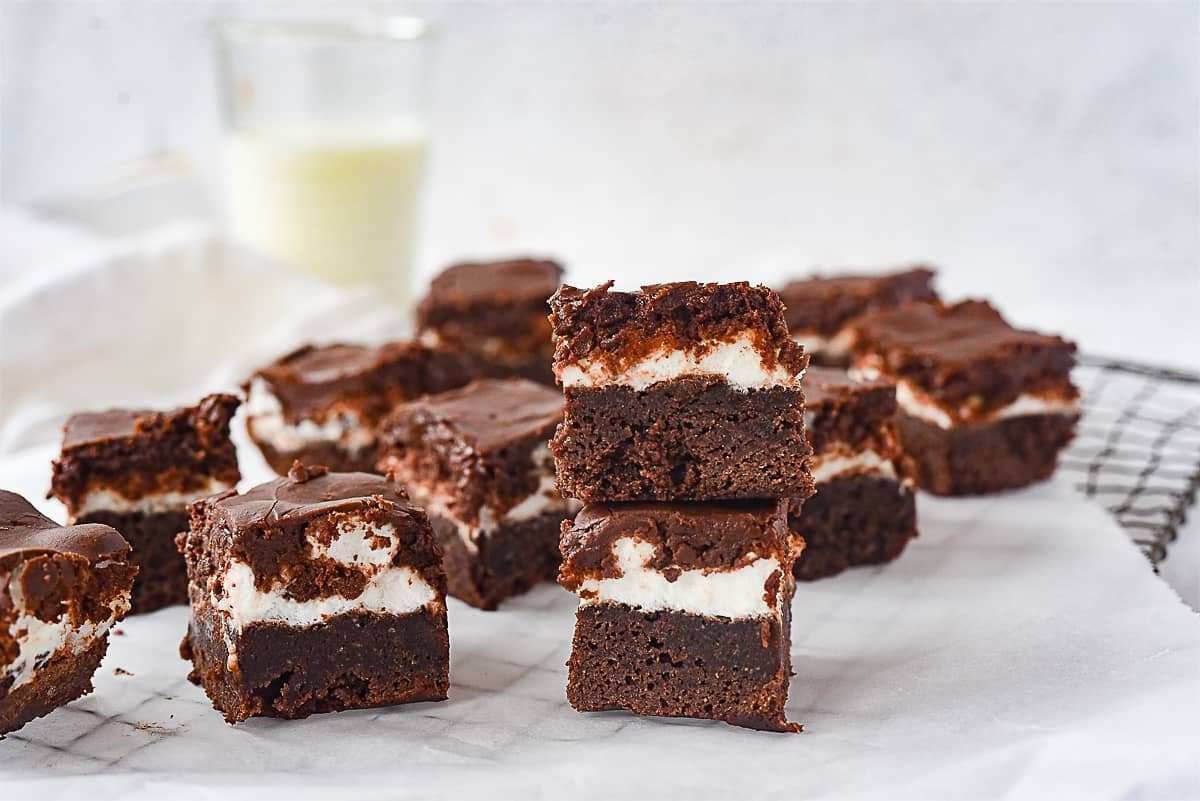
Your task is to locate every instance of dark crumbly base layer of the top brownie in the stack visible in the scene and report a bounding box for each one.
[550,378,812,502]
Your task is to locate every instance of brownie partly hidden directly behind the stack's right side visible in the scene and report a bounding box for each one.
[788,367,917,580]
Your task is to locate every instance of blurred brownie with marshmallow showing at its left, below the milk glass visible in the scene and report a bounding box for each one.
[244,342,476,475]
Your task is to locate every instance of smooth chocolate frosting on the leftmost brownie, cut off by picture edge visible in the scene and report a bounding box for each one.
[0,489,130,562]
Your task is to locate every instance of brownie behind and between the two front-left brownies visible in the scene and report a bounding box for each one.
[50,395,240,613]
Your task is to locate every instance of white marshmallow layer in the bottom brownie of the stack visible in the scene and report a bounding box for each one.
[580,537,786,619]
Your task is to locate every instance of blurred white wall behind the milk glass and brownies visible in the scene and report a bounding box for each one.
[0,0,1200,367]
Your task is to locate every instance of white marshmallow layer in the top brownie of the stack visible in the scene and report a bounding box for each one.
[556,332,803,392]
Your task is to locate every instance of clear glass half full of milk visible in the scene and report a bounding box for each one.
[217,17,428,303]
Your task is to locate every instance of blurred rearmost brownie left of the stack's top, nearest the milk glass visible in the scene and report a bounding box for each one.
[416,259,563,384]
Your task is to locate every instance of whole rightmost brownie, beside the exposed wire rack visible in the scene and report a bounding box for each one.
[852,300,1079,495]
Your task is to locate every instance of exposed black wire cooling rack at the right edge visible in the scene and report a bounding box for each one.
[1060,356,1200,570]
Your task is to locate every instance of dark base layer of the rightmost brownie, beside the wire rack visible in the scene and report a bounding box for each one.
[896,411,1079,495]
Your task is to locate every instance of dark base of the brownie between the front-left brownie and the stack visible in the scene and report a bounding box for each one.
[430,510,570,612]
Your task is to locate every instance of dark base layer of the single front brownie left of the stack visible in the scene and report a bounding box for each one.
[180,607,450,723]
